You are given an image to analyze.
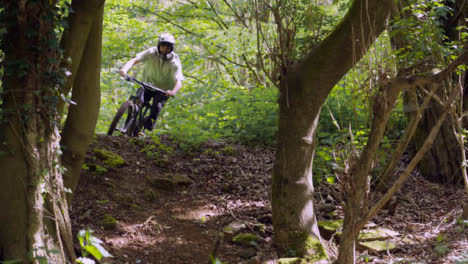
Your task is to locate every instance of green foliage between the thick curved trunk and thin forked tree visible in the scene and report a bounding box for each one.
[314,31,407,183]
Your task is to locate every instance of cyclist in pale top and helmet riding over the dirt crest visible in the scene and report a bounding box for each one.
[119,33,184,131]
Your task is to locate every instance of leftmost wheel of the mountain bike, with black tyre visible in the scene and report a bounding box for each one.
[107,101,137,136]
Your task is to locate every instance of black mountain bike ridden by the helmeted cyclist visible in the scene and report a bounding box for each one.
[107,75,166,137]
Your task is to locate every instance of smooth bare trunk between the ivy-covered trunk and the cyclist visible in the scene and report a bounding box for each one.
[61,0,104,204]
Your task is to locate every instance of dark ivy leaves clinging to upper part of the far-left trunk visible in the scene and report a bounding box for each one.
[0,0,70,130]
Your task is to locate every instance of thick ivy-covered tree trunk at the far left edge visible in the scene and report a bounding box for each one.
[0,0,75,263]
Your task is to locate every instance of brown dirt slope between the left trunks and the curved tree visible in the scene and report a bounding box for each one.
[72,135,276,263]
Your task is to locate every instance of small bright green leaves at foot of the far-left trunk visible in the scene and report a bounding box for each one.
[76,230,112,264]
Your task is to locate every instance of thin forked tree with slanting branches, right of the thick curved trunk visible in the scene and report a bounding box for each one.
[337,52,468,264]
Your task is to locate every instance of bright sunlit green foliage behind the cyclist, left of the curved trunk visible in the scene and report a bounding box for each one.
[96,0,349,149]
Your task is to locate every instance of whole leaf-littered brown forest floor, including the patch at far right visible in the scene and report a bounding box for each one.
[71,135,468,264]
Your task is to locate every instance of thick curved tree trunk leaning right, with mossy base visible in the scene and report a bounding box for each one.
[272,0,394,262]
